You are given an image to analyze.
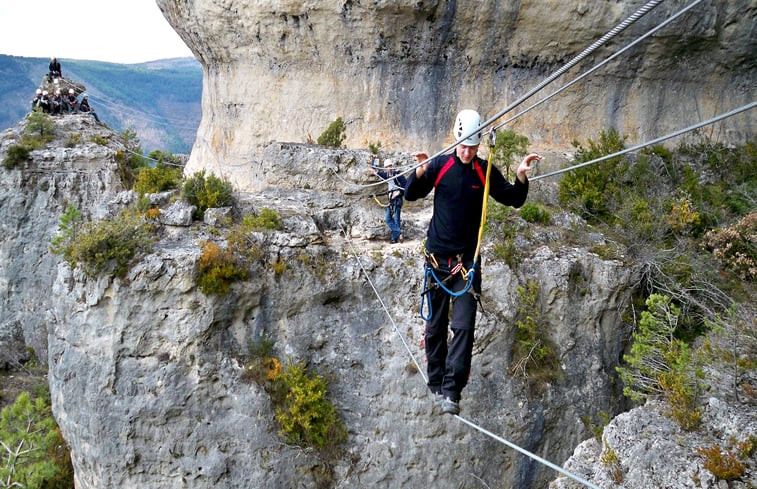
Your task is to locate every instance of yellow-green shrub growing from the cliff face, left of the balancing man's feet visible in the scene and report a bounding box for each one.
[274,362,347,451]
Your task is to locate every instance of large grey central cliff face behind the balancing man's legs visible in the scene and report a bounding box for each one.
[42,138,633,489]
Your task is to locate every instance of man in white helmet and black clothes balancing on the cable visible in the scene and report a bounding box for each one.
[405,110,542,414]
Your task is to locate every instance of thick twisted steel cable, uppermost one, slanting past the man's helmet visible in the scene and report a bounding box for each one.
[331,0,663,188]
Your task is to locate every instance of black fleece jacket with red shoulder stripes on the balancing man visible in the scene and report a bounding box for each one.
[405,155,528,260]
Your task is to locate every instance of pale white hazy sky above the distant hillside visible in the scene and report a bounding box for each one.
[0,0,193,64]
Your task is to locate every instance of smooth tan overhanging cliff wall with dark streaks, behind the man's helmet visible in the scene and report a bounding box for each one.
[157,0,757,190]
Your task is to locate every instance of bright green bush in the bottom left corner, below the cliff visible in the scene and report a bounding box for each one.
[0,386,74,489]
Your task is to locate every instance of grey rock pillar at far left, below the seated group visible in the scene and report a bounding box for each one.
[0,114,124,368]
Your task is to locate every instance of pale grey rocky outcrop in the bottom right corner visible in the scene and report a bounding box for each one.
[549,390,757,489]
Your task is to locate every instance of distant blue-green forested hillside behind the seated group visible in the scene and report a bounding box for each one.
[0,55,202,153]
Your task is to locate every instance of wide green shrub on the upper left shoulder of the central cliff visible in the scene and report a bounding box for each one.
[61,210,152,277]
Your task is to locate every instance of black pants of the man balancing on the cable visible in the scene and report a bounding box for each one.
[424,265,481,401]
